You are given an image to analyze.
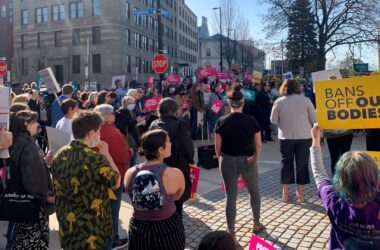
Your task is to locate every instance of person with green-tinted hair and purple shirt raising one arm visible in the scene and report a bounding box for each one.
[310,125,380,249]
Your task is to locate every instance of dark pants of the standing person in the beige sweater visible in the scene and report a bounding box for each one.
[280,139,312,185]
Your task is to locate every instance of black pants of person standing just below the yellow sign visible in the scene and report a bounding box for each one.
[327,134,353,174]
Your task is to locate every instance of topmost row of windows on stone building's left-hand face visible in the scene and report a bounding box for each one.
[21,0,100,25]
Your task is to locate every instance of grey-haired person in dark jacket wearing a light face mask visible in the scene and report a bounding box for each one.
[115,96,145,166]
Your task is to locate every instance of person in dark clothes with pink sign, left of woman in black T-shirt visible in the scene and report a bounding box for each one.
[206,82,223,138]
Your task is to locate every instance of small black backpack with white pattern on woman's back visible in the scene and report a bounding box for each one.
[132,166,166,211]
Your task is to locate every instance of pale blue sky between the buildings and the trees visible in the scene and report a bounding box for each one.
[185,0,379,70]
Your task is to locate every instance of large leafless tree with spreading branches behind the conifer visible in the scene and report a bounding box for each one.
[262,0,380,70]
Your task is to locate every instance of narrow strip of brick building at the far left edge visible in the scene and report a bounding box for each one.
[0,0,14,80]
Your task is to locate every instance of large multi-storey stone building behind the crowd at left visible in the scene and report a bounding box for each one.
[12,0,197,88]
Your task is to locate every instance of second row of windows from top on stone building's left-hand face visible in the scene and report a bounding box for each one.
[21,26,101,50]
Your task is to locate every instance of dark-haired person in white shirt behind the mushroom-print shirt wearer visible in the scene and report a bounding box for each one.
[56,99,78,136]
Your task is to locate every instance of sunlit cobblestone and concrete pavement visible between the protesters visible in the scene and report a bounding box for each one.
[0,136,365,250]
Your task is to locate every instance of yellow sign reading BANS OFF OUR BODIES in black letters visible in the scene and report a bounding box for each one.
[315,75,380,129]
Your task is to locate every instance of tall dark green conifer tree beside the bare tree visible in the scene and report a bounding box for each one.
[286,0,318,73]
